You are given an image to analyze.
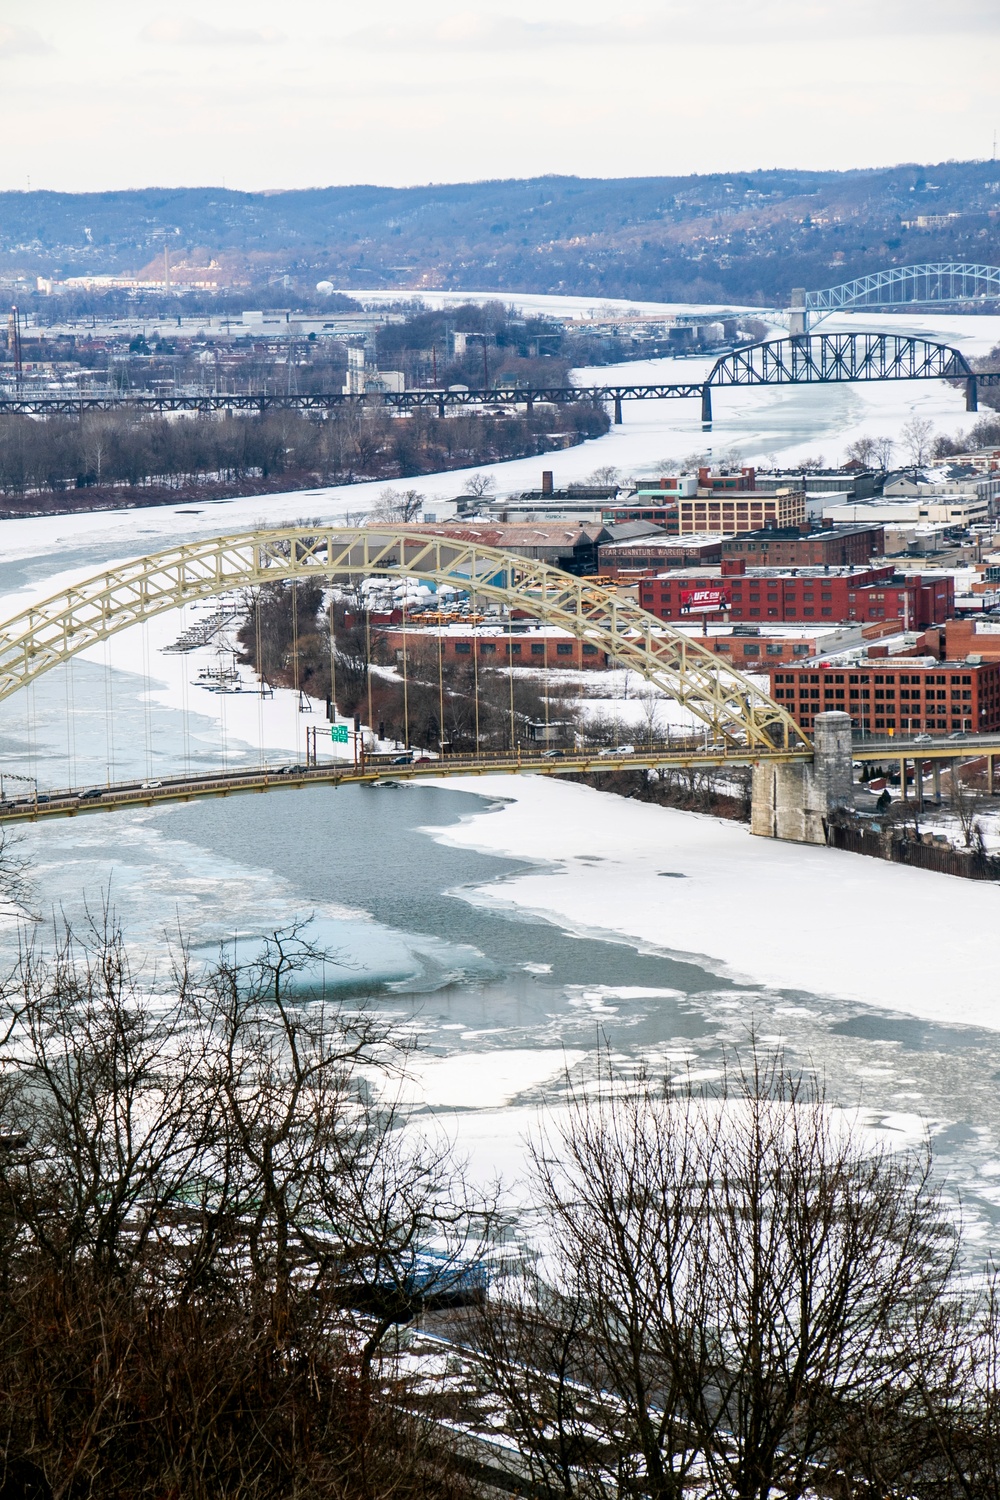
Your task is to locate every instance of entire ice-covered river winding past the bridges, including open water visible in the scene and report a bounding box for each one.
[0,301,1000,1236]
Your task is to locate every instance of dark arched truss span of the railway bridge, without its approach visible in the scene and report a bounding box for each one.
[706,333,973,389]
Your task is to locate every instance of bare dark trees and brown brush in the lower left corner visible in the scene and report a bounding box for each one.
[0,920,483,1500]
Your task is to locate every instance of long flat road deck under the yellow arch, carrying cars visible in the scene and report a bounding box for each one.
[0,747,813,824]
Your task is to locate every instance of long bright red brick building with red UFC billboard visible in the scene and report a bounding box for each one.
[639,558,955,630]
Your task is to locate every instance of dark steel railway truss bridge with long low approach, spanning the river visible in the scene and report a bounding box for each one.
[0,333,1000,423]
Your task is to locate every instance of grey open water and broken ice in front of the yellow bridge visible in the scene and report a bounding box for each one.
[0,746,1000,1250]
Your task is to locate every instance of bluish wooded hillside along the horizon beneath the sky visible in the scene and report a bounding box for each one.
[0,162,1000,305]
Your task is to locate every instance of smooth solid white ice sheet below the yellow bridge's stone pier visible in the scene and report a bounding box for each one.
[422,777,1000,1031]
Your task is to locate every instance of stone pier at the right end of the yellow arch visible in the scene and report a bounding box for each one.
[750,713,855,845]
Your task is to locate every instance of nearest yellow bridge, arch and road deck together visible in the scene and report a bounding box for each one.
[0,527,813,821]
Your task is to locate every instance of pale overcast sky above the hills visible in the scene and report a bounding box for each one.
[0,0,1000,191]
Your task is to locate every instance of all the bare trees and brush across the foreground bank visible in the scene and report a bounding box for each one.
[0,876,1000,1500]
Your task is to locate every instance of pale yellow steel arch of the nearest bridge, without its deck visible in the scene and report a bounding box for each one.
[0,527,810,755]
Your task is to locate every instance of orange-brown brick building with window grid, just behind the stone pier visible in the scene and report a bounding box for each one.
[769,656,1000,734]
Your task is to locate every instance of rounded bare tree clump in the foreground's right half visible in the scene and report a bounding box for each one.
[474,1047,1000,1500]
